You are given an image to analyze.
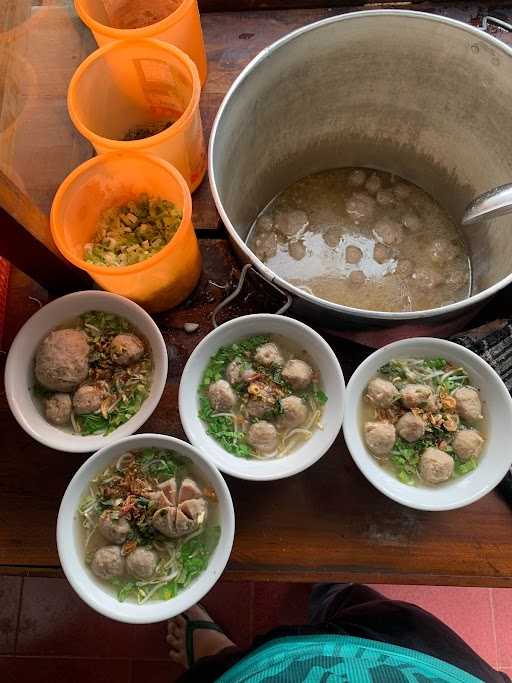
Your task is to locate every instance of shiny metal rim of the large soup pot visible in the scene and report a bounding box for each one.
[208,9,512,322]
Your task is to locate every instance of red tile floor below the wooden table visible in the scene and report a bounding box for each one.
[0,576,512,683]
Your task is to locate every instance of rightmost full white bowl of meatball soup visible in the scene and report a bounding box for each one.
[343,338,512,510]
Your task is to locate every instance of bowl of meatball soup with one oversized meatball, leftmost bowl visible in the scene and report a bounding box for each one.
[5,291,168,453]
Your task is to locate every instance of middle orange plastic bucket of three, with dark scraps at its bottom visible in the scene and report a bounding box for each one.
[68,38,206,191]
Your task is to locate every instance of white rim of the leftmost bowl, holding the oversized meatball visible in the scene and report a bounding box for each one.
[4,290,168,453]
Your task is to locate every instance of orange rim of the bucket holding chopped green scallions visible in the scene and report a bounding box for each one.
[50,151,193,276]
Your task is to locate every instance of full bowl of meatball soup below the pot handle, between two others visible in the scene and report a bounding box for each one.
[179,314,345,480]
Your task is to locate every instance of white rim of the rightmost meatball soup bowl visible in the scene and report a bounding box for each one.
[343,337,512,512]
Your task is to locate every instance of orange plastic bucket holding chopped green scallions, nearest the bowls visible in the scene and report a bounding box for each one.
[50,152,201,312]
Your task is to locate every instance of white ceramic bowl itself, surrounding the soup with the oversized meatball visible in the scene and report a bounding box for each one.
[5,291,167,453]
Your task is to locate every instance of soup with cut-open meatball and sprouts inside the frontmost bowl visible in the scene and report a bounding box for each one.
[78,448,220,604]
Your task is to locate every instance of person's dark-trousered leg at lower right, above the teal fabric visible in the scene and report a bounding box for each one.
[312,584,507,683]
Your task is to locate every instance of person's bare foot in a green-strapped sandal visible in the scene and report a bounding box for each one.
[166,605,244,683]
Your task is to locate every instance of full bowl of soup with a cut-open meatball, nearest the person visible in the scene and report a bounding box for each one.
[57,434,235,624]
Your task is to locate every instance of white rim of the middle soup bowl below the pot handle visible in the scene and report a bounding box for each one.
[179,313,346,481]
